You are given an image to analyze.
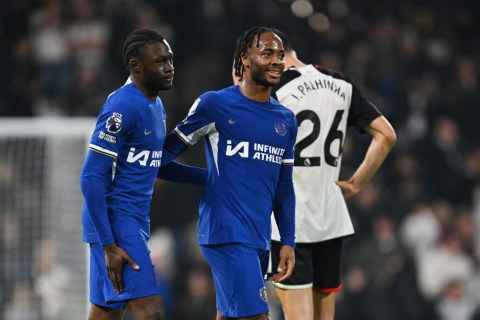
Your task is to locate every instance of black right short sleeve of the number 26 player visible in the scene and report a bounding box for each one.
[348,84,382,131]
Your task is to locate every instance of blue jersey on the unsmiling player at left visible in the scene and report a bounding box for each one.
[83,82,166,242]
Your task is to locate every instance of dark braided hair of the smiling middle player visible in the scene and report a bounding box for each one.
[233,26,284,78]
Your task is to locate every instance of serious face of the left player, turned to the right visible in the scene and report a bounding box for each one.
[136,40,174,92]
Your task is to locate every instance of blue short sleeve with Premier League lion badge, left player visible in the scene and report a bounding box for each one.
[88,97,137,159]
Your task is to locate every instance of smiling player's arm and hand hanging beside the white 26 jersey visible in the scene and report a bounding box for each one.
[273,119,297,281]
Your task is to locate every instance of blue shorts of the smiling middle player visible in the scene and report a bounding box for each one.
[201,243,269,318]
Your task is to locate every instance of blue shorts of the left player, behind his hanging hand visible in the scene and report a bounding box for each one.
[90,236,161,309]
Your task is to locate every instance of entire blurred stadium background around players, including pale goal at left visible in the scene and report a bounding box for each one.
[0,0,480,320]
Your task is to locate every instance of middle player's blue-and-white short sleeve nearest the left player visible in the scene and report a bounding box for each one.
[174,93,215,145]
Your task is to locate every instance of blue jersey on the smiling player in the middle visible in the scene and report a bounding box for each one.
[175,86,297,249]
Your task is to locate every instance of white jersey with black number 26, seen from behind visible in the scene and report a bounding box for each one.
[272,65,379,243]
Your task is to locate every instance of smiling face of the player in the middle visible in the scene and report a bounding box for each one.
[242,32,285,87]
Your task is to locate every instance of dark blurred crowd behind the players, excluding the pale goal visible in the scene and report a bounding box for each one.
[0,0,480,320]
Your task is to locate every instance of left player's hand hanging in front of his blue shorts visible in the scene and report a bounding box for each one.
[104,244,140,292]
